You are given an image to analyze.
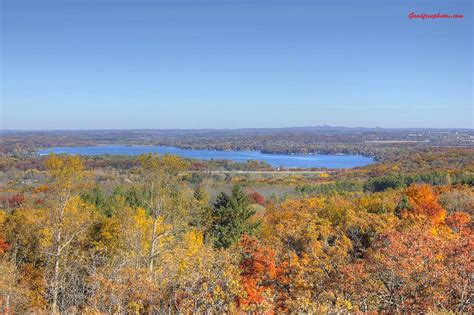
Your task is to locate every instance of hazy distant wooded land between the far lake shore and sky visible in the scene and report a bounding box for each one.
[0,127,473,160]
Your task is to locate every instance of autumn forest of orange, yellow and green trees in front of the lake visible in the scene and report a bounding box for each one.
[0,138,474,314]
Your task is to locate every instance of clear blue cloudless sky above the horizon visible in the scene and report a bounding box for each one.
[0,0,474,129]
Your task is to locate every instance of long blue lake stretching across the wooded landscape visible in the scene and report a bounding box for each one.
[38,145,374,168]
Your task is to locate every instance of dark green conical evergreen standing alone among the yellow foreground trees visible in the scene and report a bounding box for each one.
[207,186,260,248]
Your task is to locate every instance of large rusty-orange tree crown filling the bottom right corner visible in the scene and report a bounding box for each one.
[340,226,474,313]
